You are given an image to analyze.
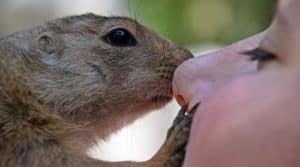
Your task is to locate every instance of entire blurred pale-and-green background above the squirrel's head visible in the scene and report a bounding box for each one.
[0,0,276,47]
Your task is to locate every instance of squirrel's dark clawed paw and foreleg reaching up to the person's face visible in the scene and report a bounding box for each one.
[164,104,199,167]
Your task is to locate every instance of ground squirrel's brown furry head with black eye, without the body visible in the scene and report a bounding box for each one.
[2,14,192,119]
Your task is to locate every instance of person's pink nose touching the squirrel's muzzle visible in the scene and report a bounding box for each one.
[172,37,258,106]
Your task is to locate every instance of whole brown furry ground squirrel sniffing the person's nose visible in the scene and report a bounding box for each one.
[0,14,192,167]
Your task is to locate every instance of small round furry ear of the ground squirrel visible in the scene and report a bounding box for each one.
[36,33,60,54]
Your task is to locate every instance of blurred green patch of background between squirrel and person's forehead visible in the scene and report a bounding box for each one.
[129,0,276,46]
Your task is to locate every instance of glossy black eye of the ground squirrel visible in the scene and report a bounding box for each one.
[103,28,137,47]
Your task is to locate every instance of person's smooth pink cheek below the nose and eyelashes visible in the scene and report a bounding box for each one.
[185,75,300,167]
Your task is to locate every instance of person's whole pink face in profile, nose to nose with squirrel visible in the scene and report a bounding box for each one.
[173,0,300,167]
